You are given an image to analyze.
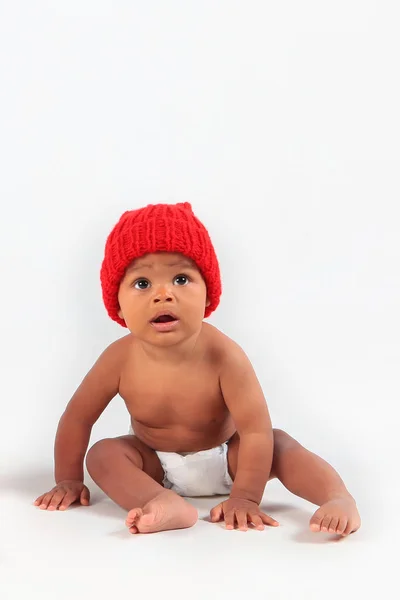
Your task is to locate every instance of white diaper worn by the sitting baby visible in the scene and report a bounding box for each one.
[129,428,233,497]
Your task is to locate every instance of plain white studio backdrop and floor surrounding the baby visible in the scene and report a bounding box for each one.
[0,0,400,600]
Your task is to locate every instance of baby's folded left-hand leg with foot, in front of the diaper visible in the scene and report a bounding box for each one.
[86,435,197,533]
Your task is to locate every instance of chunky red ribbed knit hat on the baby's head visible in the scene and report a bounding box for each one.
[100,202,221,327]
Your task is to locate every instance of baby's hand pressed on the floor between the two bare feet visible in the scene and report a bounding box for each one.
[210,498,279,531]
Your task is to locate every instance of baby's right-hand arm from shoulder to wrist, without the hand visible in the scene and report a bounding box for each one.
[220,341,274,504]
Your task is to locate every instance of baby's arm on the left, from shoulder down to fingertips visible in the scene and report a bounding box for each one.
[35,338,126,510]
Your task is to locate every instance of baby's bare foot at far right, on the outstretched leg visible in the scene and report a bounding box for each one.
[310,496,361,536]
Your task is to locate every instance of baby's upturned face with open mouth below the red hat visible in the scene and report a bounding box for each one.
[118,252,210,346]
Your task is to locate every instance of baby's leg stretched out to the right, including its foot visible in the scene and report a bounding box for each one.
[271,429,361,535]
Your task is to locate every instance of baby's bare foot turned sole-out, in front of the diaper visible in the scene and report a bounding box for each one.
[125,490,198,533]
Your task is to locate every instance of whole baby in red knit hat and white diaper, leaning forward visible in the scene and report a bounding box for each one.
[35,203,361,536]
